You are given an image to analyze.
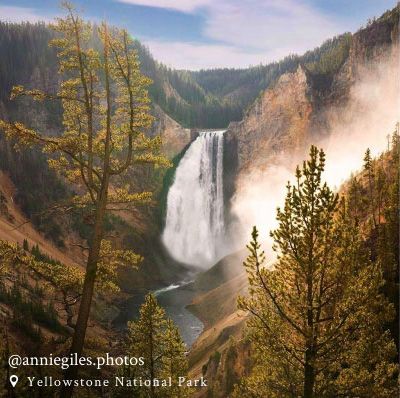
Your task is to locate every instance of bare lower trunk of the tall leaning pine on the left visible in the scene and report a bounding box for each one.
[60,185,108,398]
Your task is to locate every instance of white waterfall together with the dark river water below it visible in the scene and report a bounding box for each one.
[125,131,225,347]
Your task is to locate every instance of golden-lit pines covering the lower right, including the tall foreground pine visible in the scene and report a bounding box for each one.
[232,130,400,398]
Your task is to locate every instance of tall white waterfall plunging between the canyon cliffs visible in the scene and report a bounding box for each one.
[162,131,224,268]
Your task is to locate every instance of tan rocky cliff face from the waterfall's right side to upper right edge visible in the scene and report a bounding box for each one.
[226,9,399,187]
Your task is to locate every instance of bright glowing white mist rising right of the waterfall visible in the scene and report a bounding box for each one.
[232,49,400,253]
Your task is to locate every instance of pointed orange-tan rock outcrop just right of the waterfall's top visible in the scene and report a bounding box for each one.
[226,66,313,173]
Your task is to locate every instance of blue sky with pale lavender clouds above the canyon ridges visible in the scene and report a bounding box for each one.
[0,0,397,70]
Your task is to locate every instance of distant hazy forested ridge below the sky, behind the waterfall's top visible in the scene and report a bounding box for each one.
[158,33,351,128]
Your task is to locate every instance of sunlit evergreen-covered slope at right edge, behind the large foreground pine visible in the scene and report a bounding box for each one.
[347,124,400,349]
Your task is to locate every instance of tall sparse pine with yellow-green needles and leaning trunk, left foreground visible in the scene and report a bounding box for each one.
[0,3,169,398]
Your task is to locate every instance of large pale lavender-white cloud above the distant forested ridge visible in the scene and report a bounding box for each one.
[141,0,346,70]
